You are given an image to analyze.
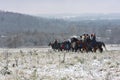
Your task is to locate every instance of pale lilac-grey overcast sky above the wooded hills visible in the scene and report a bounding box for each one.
[0,0,120,14]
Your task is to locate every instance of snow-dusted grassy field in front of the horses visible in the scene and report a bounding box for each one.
[0,45,120,80]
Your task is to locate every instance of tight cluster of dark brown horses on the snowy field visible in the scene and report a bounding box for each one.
[49,38,106,53]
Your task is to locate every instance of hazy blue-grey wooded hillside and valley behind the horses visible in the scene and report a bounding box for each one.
[0,11,120,48]
